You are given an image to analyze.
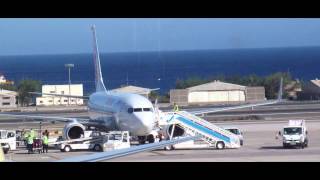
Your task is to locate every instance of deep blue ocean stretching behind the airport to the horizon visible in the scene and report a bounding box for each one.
[0,47,320,94]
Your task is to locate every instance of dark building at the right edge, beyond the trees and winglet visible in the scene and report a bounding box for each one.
[298,78,320,100]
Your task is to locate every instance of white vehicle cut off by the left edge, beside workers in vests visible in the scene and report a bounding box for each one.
[0,130,17,154]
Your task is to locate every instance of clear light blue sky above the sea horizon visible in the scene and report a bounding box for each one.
[0,18,320,55]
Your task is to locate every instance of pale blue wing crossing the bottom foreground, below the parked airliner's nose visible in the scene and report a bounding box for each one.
[58,136,200,162]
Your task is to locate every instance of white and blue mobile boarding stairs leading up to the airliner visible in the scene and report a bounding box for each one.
[165,111,240,148]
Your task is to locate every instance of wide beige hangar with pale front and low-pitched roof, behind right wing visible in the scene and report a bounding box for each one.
[170,81,265,105]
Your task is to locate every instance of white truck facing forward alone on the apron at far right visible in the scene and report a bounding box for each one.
[279,120,308,148]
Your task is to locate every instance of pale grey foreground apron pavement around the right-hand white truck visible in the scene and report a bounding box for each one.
[6,120,320,162]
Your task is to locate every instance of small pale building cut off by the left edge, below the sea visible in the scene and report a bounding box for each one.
[0,88,18,108]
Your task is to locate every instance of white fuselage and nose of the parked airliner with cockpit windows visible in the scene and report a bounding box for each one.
[88,91,156,136]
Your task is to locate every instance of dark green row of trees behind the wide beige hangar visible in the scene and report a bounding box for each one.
[176,72,292,99]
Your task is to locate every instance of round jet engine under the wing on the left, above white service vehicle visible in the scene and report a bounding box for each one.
[63,122,86,140]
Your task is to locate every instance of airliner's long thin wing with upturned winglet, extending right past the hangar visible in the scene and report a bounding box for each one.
[188,78,283,115]
